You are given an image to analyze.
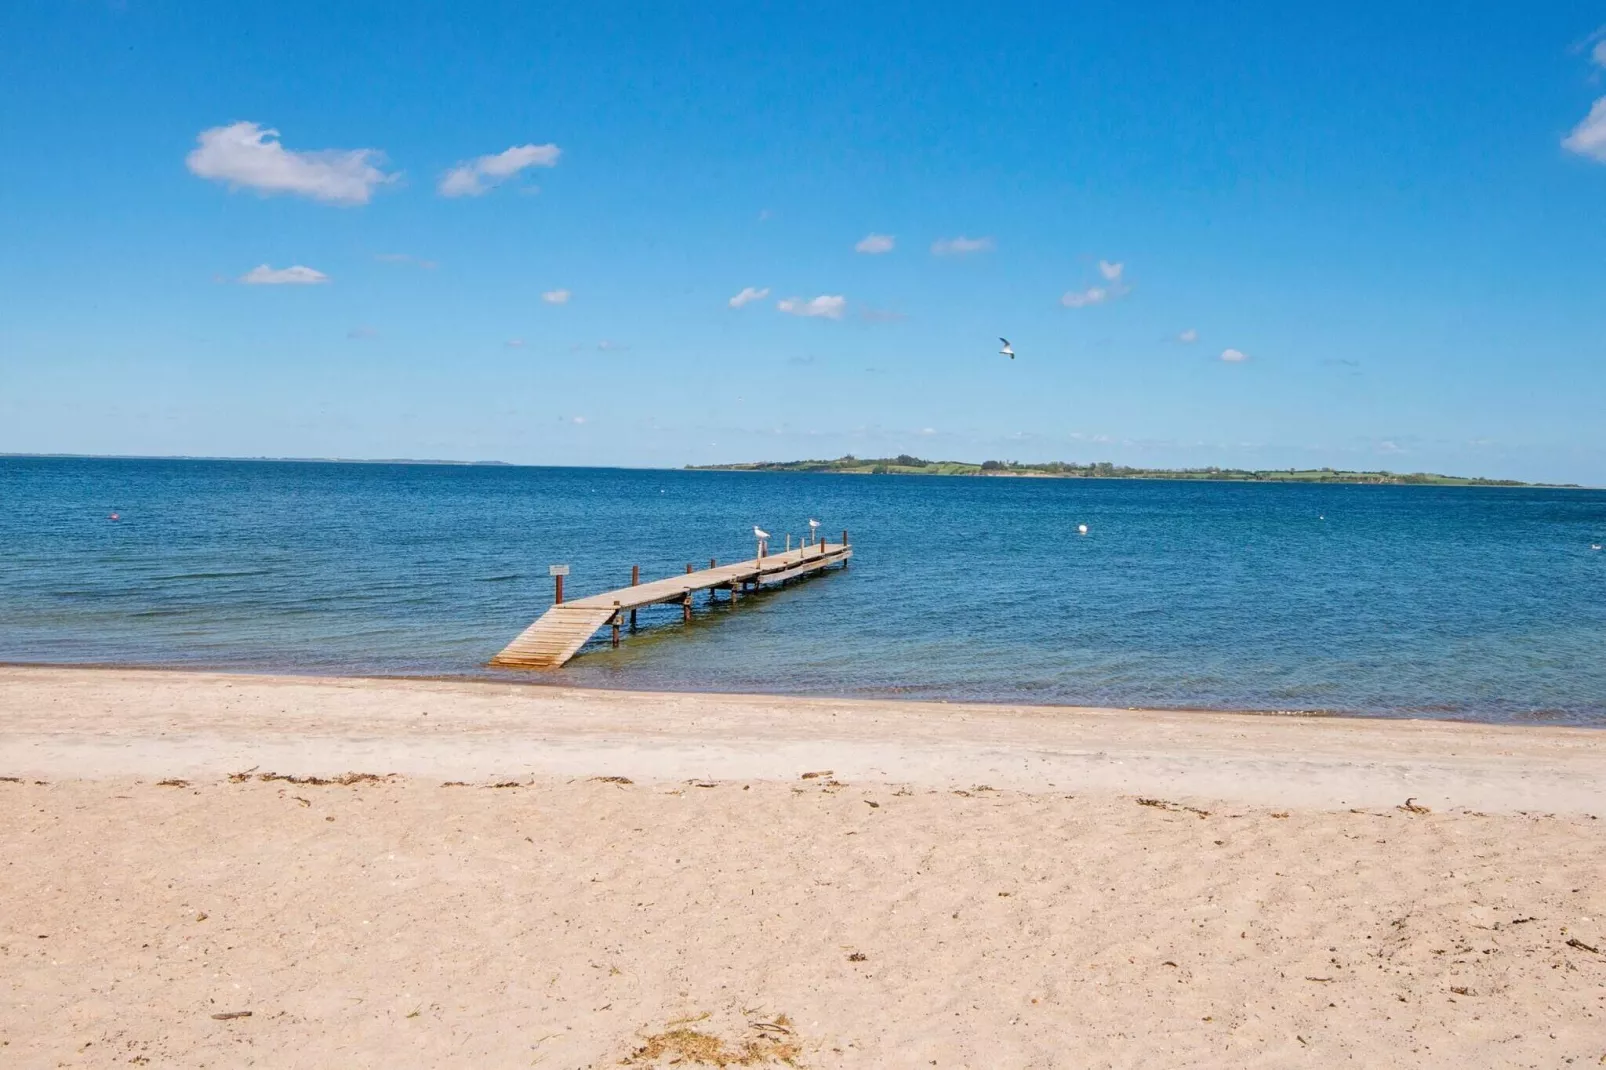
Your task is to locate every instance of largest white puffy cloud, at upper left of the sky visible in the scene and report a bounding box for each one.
[185,122,397,204]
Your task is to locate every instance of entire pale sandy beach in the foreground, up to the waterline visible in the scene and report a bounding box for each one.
[0,668,1606,1067]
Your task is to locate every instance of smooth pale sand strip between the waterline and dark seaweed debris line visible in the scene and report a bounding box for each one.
[9,667,1606,813]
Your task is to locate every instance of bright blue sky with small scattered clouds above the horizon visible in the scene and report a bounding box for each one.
[0,0,1606,484]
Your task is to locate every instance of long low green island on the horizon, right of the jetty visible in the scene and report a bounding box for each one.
[686,453,1575,487]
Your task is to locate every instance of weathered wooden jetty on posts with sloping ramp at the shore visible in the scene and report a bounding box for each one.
[491,532,853,668]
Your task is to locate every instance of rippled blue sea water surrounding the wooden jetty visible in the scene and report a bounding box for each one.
[0,458,1606,726]
